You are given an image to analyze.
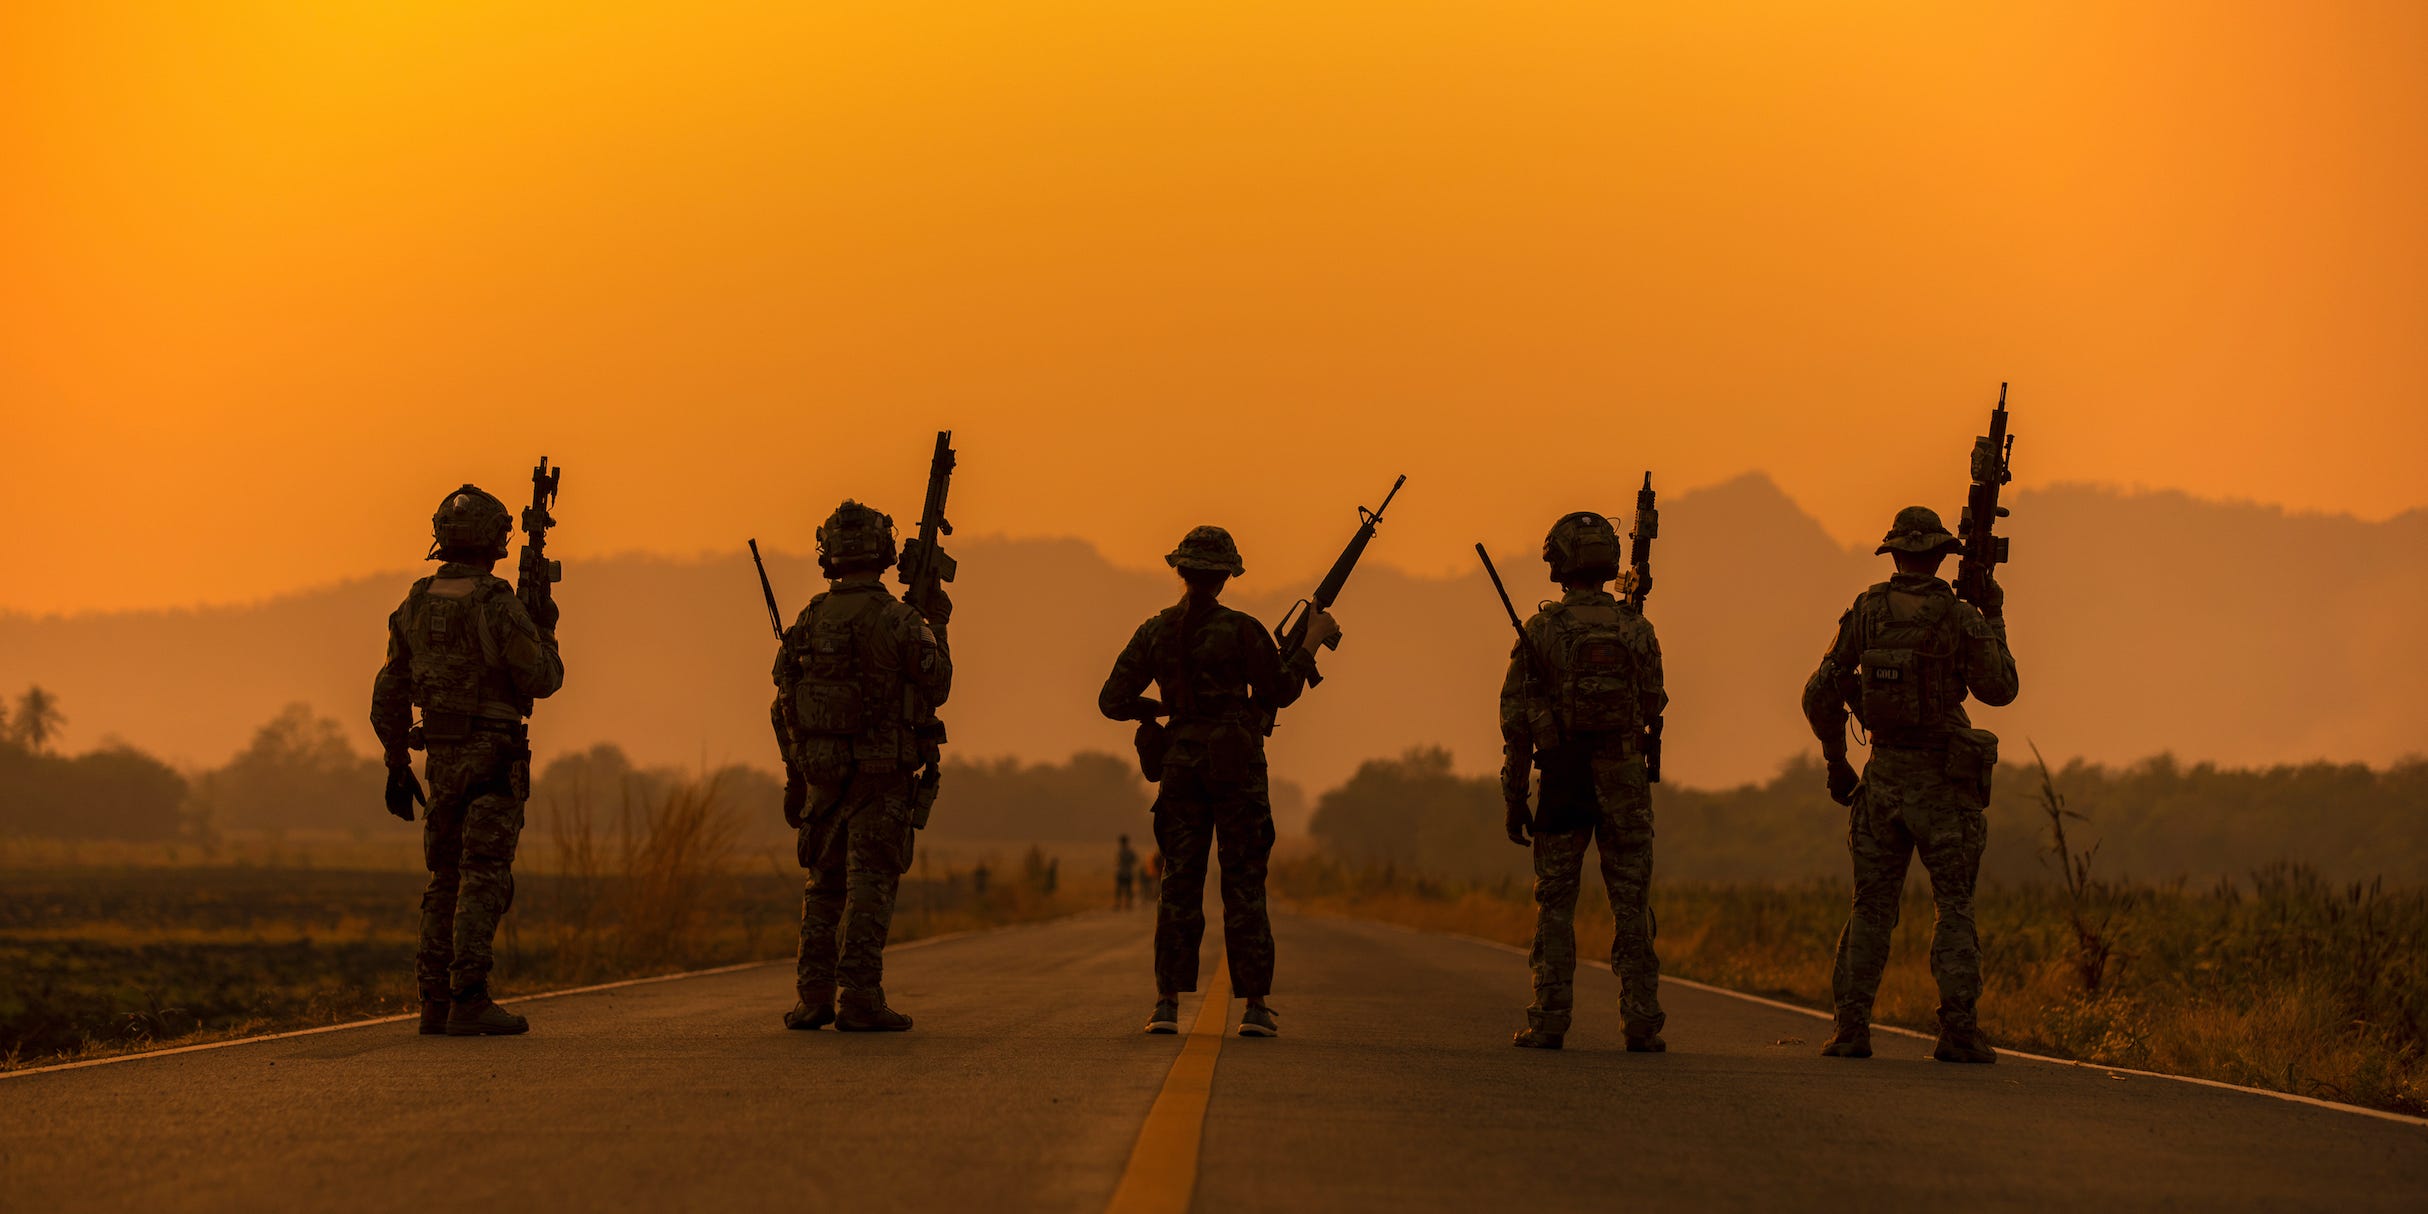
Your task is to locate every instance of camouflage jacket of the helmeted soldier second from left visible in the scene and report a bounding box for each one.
[770,573,952,784]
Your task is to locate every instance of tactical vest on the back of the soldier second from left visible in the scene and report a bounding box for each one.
[787,590,927,784]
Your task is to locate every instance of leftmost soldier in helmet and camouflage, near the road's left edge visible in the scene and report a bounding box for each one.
[371,486,566,1037]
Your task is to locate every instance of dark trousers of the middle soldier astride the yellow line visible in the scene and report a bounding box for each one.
[1156,767,1272,998]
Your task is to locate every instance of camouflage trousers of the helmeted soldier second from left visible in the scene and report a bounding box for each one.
[794,772,911,993]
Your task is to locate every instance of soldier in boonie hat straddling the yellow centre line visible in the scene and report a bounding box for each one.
[1097,527,1340,1037]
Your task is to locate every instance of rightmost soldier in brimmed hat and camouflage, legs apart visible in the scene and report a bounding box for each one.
[1804,505,2015,1063]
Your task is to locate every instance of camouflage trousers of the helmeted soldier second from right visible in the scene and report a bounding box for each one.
[1525,755,1668,1037]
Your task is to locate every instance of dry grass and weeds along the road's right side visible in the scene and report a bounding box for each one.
[1272,857,2428,1114]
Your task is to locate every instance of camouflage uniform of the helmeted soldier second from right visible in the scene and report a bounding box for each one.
[1501,588,1668,1042]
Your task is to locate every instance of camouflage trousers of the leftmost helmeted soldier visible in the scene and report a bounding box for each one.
[413,733,532,1000]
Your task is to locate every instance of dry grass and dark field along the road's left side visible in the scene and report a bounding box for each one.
[0,777,1097,1071]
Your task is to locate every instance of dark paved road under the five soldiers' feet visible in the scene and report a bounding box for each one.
[0,911,2428,1214]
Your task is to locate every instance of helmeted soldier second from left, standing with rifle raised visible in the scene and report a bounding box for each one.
[772,500,946,1032]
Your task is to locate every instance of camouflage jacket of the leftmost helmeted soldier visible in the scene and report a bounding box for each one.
[371,561,566,762]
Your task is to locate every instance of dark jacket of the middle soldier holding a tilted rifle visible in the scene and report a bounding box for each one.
[1095,597,1316,777]
